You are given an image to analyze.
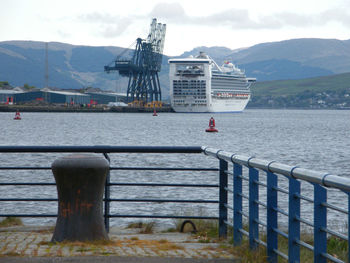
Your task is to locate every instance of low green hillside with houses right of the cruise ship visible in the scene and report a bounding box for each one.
[248,73,350,108]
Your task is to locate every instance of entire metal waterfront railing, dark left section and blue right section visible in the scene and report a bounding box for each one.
[0,146,350,263]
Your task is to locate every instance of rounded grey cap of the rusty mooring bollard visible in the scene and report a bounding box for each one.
[51,153,109,169]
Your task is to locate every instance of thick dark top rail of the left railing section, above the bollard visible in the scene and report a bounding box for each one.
[0,145,203,153]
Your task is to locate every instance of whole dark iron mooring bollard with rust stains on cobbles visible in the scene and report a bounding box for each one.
[51,154,109,242]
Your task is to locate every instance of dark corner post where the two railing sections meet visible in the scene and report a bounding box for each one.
[219,160,228,238]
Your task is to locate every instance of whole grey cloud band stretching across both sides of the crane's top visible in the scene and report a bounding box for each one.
[76,3,350,38]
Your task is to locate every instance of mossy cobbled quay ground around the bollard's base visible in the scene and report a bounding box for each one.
[0,226,239,263]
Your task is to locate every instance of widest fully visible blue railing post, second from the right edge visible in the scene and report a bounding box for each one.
[314,184,327,263]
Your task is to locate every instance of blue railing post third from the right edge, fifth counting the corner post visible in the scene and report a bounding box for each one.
[288,178,300,262]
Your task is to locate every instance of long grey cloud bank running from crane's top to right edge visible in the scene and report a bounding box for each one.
[150,3,350,30]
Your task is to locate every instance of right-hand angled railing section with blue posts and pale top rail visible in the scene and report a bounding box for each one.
[203,147,350,263]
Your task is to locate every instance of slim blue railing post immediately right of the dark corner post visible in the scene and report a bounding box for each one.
[233,163,243,245]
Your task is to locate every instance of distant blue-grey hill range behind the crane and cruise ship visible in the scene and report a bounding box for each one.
[0,39,350,99]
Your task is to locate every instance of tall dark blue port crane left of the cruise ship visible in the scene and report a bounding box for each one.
[104,18,166,107]
